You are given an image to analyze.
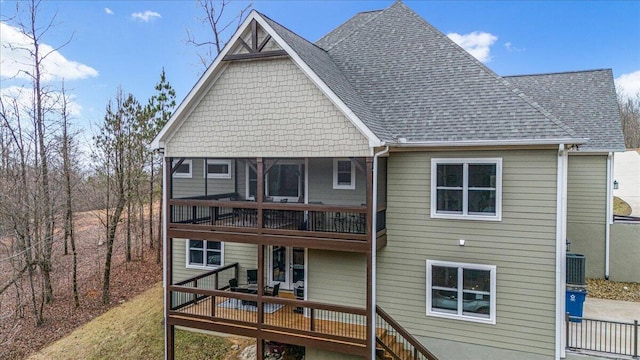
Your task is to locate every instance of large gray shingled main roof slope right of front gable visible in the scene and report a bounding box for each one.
[318,2,580,145]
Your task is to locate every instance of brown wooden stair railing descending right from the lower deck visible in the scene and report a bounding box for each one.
[376,306,438,360]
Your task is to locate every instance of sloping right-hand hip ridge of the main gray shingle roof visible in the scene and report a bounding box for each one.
[392,2,579,136]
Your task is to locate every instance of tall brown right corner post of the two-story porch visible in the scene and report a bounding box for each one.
[366,157,376,359]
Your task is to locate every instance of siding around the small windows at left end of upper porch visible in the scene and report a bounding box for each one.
[172,158,238,199]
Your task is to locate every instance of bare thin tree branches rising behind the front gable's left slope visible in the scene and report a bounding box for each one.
[185,0,253,69]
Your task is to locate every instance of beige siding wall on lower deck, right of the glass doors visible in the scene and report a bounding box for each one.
[305,250,367,307]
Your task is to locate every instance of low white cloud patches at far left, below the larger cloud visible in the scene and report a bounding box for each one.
[0,86,82,119]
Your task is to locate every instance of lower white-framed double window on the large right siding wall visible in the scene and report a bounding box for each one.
[427,260,496,325]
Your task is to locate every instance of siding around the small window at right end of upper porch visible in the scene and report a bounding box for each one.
[309,158,367,206]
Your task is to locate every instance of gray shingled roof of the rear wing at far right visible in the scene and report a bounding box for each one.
[504,69,625,151]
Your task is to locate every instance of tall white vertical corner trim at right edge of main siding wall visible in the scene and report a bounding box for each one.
[555,144,569,359]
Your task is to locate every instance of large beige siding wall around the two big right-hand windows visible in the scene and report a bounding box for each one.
[378,150,557,356]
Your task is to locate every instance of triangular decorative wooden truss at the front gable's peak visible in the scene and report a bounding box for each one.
[222,19,287,61]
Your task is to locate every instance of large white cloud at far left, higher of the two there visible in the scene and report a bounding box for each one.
[0,22,98,81]
